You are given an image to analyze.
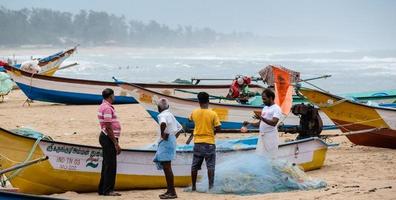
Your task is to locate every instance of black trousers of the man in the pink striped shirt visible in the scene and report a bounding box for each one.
[98,132,117,195]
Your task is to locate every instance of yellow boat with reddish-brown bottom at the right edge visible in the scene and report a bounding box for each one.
[299,88,396,149]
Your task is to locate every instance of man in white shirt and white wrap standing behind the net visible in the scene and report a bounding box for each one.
[243,89,282,157]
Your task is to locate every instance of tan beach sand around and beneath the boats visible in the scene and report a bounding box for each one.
[0,90,396,200]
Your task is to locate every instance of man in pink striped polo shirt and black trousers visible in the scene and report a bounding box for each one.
[98,88,121,196]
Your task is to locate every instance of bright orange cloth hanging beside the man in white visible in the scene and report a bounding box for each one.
[272,66,293,115]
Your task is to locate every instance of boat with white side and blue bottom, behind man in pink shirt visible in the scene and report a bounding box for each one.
[5,66,262,105]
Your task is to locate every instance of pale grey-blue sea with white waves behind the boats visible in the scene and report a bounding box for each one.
[0,47,396,94]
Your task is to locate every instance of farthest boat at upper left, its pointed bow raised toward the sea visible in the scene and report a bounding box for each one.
[0,46,77,76]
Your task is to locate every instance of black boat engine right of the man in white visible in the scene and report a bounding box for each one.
[278,103,323,140]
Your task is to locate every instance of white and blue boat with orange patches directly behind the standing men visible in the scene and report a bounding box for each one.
[119,83,334,130]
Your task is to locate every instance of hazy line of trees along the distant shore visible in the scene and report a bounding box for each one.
[0,7,255,47]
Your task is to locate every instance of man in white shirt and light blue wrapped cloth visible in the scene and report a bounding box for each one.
[154,98,182,199]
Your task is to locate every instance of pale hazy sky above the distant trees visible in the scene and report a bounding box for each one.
[0,0,396,49]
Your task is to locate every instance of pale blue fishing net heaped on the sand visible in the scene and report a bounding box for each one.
[191,153,326,195]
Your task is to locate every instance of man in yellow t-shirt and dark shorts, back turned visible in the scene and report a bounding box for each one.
[190,92,221,191]
